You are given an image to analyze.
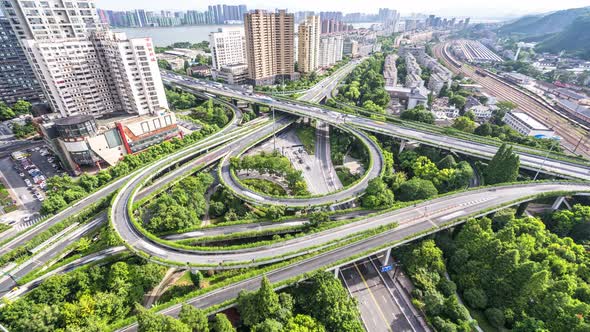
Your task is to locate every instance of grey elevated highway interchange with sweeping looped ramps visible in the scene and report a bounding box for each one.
[0,47,590,330]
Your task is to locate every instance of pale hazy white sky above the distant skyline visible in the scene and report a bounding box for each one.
[97,0,590,17]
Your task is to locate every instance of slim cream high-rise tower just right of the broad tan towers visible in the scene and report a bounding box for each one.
[297,16,321,73]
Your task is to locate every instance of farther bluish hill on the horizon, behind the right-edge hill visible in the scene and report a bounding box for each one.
[498,7,590,37]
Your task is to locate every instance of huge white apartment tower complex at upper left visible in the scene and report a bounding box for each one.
[0,0,168,116]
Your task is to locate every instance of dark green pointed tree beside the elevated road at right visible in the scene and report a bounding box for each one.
[484,144,520,184]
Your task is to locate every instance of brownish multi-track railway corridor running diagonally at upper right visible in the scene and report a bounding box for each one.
[434,45,590,157]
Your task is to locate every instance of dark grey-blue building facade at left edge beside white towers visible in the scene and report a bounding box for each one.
[0,17,43,104]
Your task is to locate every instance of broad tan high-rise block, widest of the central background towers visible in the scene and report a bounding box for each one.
[244,10,295,85]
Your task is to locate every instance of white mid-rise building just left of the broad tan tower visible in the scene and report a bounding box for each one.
[209,27,246,70]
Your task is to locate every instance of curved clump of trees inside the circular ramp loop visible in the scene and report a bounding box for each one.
[230,151,309,196]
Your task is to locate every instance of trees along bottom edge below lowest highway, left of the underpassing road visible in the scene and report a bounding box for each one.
[138,272,364,332]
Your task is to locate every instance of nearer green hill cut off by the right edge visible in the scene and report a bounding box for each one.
[535,14,590,60]
